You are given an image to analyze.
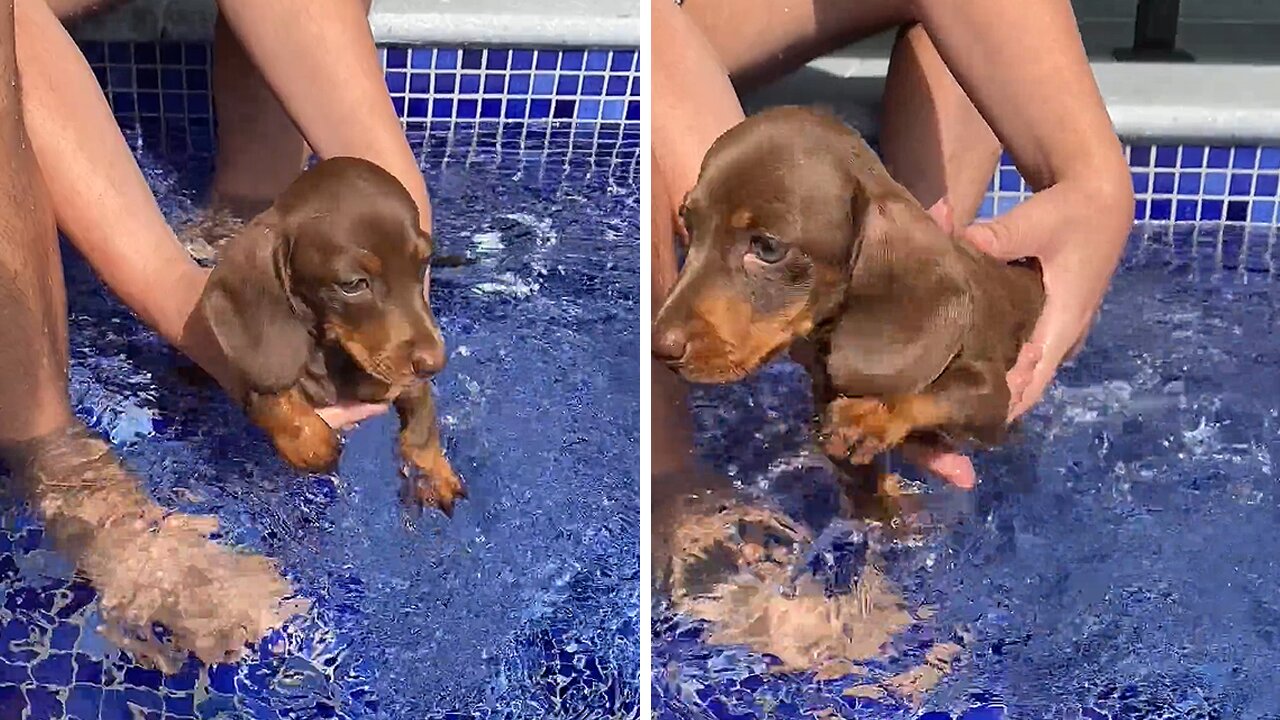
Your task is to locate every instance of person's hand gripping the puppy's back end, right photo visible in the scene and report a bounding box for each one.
[902,178,1133,488]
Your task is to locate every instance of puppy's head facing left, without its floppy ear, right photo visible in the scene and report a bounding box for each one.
[653,108,892,382]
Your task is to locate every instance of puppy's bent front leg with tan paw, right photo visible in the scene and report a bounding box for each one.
[820,360,1009,465]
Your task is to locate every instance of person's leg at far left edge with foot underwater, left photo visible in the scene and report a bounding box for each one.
[0,0,298,669]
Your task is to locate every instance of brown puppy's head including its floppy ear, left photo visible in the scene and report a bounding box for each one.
[202,158,444,392]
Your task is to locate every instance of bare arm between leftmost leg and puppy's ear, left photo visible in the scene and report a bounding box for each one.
[15,0,225,386]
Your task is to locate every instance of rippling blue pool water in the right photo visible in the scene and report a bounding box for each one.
[654,225,1280,720]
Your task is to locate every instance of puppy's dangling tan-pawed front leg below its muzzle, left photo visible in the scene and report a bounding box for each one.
[396,382,467,518]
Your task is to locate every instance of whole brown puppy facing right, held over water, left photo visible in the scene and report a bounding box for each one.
[198,158,466,515]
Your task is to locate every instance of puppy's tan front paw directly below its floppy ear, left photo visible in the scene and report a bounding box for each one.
[244,386,339,473]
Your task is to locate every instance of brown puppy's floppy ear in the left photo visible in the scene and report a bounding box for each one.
[200,210,314,392]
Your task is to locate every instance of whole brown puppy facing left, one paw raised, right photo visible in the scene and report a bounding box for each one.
[653,108,1043,499]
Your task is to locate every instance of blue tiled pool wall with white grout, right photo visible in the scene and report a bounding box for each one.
[979,145,1280,225]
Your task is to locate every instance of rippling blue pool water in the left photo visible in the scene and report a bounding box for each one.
[0,128,639,720]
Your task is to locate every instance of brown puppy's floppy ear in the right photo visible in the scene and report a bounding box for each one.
[827,188,972,397]
